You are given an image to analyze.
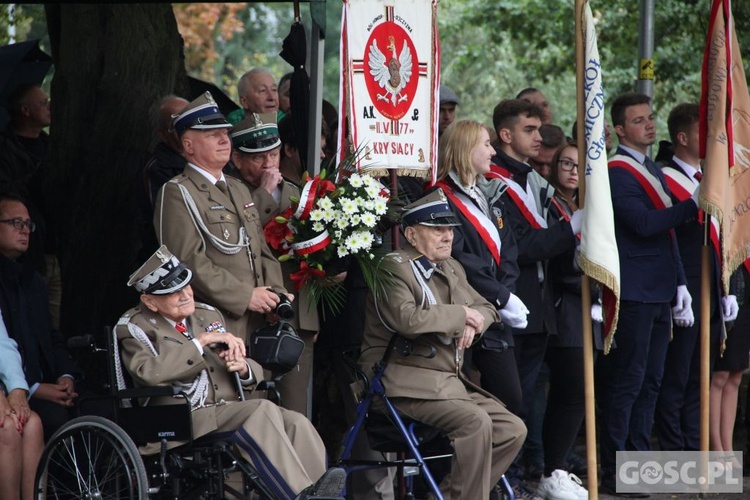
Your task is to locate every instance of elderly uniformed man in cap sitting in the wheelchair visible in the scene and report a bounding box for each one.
[116,246,345,499]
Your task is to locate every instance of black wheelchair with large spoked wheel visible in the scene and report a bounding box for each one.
[35,328,274,500]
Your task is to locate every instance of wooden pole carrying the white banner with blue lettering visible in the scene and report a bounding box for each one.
[575,0,599,500]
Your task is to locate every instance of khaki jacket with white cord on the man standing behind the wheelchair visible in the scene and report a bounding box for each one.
[154,165,285,341]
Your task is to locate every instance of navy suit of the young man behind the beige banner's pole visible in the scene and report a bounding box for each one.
[654,159,722,451]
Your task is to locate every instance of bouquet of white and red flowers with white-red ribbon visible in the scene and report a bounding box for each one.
[264,170,390,313]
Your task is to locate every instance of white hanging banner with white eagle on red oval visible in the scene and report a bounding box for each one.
[338,0,440,180]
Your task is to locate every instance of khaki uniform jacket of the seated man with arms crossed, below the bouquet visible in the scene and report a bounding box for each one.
[359,244,497,400]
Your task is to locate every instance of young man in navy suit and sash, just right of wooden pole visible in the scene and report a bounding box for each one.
[599,93,698,494]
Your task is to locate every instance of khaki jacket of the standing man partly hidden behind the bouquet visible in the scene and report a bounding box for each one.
[245,181,320,332]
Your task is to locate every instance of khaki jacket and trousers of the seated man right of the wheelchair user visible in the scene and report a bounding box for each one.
[359,245,526,500]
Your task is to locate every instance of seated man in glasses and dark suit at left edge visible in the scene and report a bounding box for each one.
[0,194,80,439]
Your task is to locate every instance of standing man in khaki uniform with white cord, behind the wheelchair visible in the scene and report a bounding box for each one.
[154,92,286,342]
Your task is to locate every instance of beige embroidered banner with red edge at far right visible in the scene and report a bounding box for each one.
[700,0,750,293]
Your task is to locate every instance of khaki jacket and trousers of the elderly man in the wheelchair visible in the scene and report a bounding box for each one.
[116,303,326,498]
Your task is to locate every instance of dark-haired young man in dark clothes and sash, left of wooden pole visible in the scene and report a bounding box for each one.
[486,99,583,497]
